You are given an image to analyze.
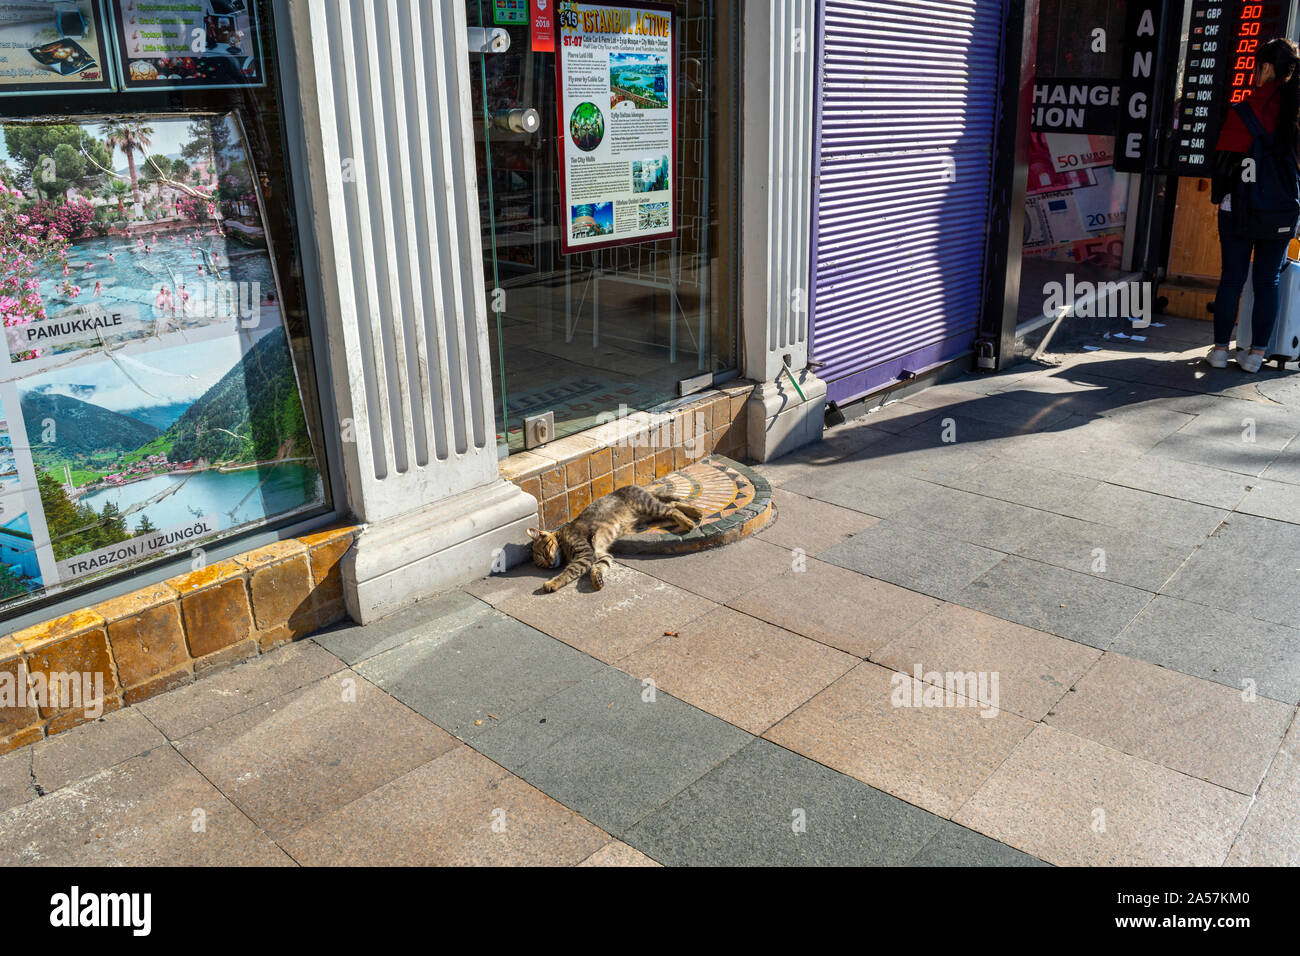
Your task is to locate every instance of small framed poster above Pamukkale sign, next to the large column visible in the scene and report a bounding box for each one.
[112,0,267,90]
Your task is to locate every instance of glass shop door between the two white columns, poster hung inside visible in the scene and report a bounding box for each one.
[467,0,740,455]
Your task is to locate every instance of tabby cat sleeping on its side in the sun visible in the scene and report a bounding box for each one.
[528,485,705,592]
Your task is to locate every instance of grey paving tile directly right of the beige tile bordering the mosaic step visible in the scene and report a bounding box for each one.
[820,520,1005,601]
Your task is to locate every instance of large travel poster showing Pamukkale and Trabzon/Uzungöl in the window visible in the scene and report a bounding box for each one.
[0,113,325,605]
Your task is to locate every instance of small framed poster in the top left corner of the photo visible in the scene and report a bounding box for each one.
[0,0,113,96]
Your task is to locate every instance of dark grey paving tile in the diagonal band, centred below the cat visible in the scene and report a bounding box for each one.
[475,669,753,836]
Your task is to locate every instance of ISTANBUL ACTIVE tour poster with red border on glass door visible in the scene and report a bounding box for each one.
[555,3,677,255]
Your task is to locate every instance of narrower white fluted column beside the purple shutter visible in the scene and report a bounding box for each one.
[741,0,826,462]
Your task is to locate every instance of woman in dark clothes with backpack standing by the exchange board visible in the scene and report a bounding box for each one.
[1208,36,1300,372]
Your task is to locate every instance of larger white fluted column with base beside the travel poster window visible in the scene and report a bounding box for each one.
[290,0,537,623]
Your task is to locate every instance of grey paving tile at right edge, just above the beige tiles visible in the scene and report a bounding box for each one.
[1110,596,1300,704]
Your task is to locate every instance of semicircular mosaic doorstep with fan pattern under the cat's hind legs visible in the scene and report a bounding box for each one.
[611,455,776,554]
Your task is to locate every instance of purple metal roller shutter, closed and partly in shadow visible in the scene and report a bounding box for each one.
[811,0,1009,402]
